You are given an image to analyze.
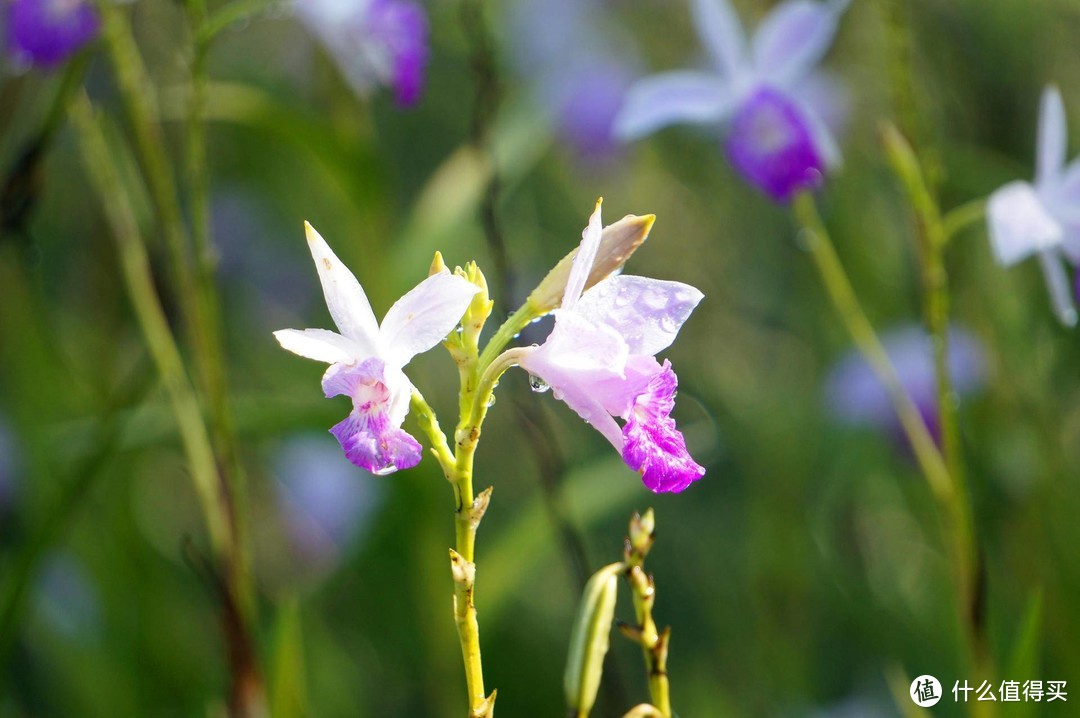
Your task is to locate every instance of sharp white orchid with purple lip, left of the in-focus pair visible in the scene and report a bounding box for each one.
[274,223,480,475]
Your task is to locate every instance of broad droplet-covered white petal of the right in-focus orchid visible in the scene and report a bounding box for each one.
[575,275,703,356]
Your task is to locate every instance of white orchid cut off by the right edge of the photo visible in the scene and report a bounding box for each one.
[986,87,1080,326]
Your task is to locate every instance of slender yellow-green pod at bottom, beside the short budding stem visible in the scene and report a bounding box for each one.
[563,561,626,718]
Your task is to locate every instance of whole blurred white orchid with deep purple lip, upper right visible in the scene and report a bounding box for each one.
[615,0,850,202]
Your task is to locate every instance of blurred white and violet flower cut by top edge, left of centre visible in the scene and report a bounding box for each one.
[295,0,428,107]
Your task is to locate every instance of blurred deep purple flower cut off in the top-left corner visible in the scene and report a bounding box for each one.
[5,0,98,69]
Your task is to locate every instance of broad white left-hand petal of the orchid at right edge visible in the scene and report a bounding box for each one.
[986,181,1065,267]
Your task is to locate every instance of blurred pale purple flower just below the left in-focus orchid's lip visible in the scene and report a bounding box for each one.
[274,436,381,564]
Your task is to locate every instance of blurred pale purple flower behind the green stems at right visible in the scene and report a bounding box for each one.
[825,324,986,438]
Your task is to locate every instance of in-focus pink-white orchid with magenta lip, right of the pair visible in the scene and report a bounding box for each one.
[519,203,705,492]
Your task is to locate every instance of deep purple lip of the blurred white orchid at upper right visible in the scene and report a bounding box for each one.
[725,87,825,202]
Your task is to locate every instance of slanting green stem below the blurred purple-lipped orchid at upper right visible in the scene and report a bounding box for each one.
[793,193,953,503]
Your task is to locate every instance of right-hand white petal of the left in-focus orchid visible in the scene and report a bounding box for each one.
[379,271,480,368]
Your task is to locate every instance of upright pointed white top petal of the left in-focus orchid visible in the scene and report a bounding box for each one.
[303,222,379,356]
